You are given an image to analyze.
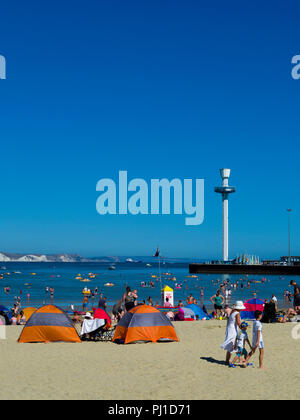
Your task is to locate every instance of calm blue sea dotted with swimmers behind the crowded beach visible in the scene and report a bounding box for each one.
[0,263,291,309]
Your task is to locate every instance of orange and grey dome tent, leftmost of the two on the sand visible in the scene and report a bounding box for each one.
[19,305,81,343]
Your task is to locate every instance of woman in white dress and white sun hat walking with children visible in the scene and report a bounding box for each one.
[221,300,246,366]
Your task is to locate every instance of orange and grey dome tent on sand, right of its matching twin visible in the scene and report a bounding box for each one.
[113,305,179,344]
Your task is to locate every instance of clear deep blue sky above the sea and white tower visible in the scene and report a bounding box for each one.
[0,0,300,258]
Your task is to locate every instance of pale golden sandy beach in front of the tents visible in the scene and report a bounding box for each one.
[0,321,300,400]
